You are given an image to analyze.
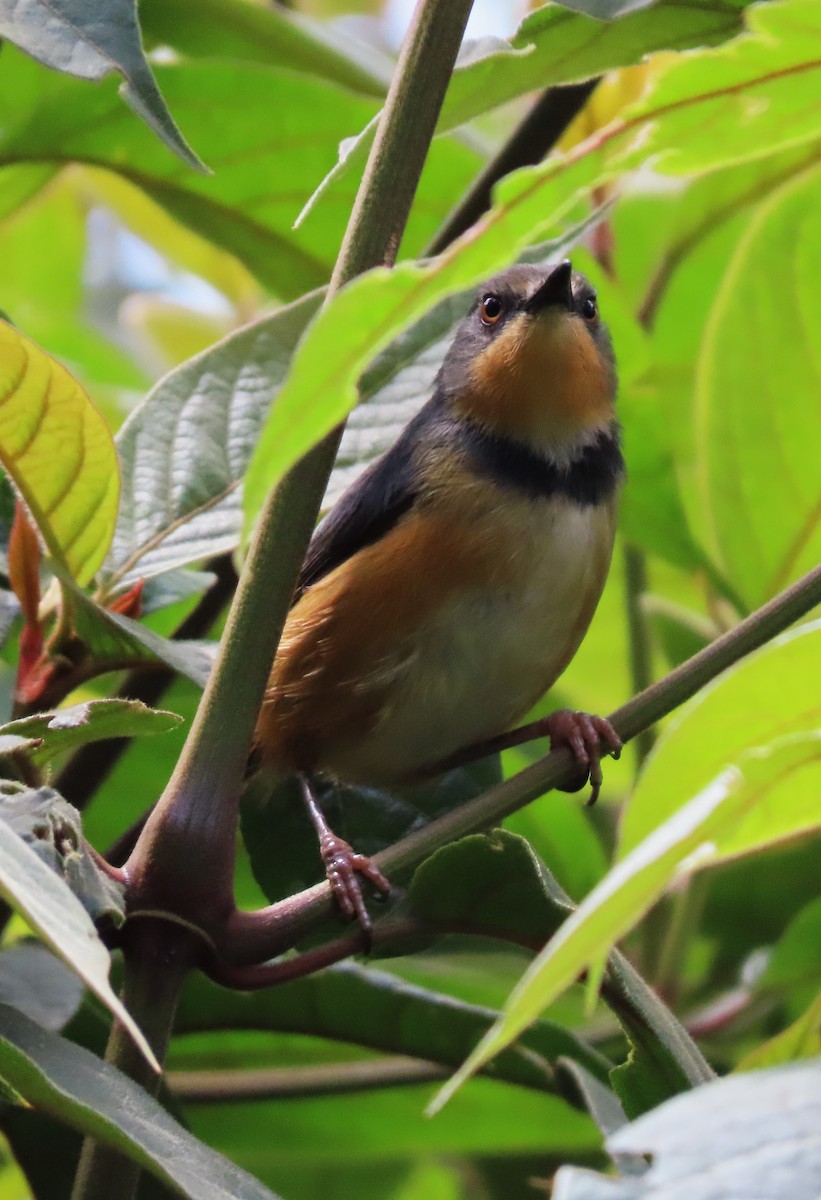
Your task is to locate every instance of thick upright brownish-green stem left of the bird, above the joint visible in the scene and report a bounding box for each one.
[127,0,472,922]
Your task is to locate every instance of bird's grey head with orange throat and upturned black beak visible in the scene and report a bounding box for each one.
[441,259,616,455]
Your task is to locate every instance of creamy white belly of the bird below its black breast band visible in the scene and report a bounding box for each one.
[333,499,613,782]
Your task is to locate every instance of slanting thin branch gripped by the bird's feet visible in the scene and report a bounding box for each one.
[224,566,821,964]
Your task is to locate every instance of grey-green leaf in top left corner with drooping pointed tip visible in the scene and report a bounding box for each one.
[0,0,206,172]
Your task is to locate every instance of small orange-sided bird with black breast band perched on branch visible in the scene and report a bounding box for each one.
[254,260,624,931]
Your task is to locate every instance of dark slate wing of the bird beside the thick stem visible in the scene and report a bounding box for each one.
[293,427,421,604]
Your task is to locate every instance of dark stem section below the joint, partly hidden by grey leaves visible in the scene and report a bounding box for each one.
[71,920,199,1200]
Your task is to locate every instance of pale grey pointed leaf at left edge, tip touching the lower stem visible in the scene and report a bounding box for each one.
[0,806,158,1069]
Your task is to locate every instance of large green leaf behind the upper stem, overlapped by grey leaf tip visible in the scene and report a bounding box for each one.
[0,49,480,300]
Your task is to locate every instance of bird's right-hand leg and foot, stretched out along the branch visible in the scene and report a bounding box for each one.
[425,708,622,805]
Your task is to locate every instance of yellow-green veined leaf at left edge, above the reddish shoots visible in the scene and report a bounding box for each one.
[0,322,119,583]
